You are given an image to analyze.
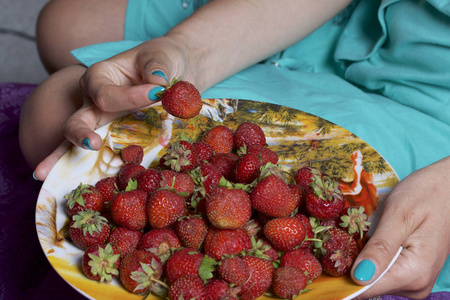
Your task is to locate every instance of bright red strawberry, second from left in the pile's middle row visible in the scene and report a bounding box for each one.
[110,190,147,230]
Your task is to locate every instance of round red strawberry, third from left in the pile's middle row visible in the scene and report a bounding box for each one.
[145,190,185,228]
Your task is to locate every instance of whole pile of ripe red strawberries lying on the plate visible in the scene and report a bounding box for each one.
[65,122,369,300]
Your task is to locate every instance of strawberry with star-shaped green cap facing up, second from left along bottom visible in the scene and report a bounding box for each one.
[119,250,163,294]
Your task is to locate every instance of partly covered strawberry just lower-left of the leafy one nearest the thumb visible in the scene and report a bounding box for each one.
[280,249,322,281]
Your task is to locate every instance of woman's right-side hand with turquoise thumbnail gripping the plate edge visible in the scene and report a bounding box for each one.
[352,156,450,299]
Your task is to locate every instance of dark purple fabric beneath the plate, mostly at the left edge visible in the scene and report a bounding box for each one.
[0,83,450,300]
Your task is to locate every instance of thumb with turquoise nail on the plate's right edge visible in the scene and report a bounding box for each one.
[351,200,408,285]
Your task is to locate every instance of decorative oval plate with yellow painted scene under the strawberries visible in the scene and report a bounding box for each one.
[36,99,398,300]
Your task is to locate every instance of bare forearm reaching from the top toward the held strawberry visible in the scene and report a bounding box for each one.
[166,0,352,91]
